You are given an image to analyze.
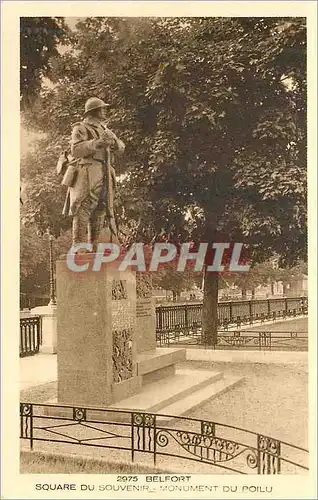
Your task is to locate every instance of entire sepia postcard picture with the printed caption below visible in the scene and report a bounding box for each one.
[1,2,316,498]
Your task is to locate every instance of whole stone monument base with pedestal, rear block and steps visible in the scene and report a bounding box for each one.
[46,254,238,421]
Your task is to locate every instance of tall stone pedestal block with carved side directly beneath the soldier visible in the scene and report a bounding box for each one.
[56,254,141,407]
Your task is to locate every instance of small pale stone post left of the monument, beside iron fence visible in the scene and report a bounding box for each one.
[31,304,57,354]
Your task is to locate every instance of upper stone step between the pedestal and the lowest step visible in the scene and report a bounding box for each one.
[111,368,223,413]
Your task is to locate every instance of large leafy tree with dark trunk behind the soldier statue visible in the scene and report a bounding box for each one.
[21,18,306,341]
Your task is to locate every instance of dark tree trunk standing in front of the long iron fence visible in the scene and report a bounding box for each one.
[202,272,219,345]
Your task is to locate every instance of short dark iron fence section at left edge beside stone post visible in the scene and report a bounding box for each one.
[20,316,42,357]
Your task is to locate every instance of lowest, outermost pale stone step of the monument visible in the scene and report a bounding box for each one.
[157,376,244,423]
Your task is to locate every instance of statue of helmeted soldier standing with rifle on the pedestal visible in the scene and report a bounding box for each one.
[63,97,125,247]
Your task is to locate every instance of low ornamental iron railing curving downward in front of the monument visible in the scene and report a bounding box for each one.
[20,402,309,475]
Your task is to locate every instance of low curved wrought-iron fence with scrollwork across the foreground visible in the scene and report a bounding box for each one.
[20,403,309,474]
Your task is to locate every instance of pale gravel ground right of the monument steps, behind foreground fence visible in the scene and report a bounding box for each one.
[187,361,308,448]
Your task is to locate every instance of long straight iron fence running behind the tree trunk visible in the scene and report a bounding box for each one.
[156,297,308,336]
